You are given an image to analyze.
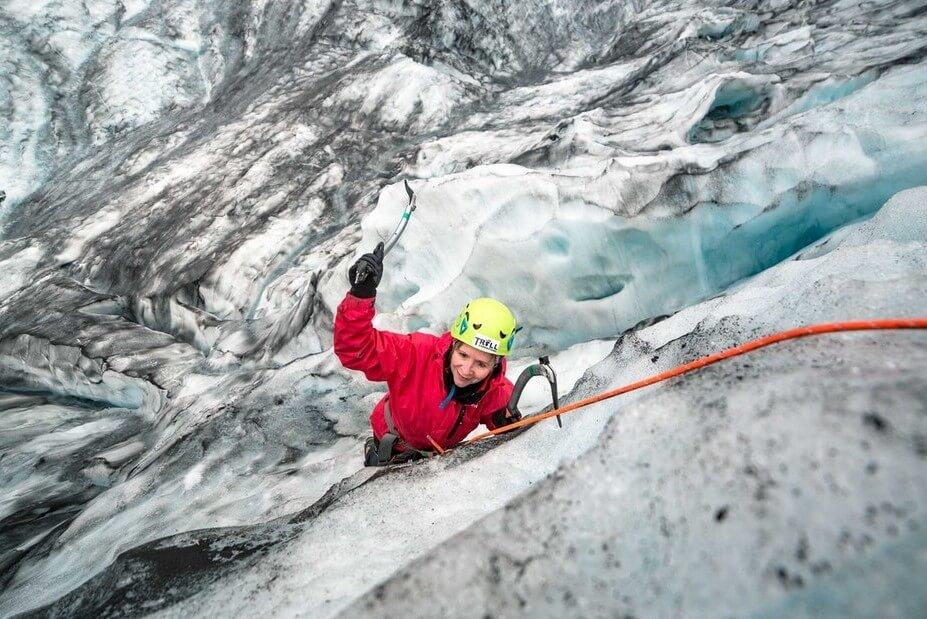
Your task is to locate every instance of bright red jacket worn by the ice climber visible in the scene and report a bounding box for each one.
[334,294,514,450]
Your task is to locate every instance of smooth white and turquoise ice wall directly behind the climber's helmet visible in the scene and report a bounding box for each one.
[350,61,927,351]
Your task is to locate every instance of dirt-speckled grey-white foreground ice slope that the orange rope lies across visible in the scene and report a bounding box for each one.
[21,188,927,617]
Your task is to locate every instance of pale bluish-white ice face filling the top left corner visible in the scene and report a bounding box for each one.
[0,0,260,215]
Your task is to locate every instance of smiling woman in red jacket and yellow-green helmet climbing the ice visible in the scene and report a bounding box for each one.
[334,243,520,466]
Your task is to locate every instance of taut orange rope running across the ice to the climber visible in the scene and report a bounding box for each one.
[462,318,927,451]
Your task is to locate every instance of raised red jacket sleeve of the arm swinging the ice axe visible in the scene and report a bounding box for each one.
[334,293,414,381]
